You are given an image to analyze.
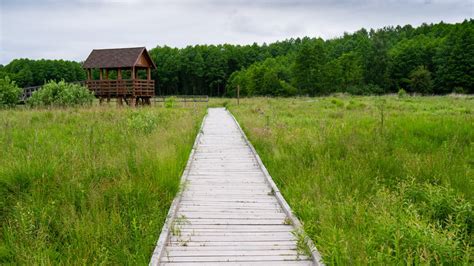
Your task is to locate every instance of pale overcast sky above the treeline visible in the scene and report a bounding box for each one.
[0,0,474,64]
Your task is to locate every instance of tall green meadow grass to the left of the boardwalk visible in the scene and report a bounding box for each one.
[0,106,205,265]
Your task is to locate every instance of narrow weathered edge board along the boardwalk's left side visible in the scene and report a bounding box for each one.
[149,110,208,266]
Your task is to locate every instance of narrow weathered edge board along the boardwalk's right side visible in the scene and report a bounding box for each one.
[226,108,324,265]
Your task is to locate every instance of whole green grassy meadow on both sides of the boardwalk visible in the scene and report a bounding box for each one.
[0,95,474,265]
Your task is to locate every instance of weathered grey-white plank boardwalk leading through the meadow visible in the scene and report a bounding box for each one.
[150,108,320,265]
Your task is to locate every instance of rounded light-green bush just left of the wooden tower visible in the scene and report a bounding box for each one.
[27,81,94,106]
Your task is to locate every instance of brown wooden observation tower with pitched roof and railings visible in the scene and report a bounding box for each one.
[83,47,156,106]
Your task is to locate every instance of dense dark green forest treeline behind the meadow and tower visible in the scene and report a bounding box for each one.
[0,19,474,96]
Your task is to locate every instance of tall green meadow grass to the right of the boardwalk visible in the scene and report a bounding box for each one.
[228,96,474,265]
